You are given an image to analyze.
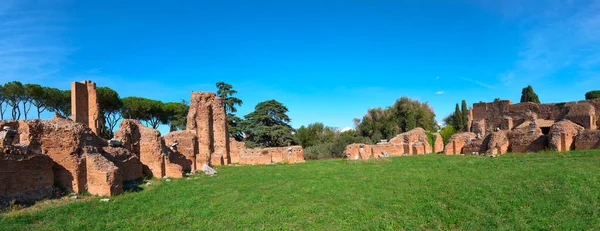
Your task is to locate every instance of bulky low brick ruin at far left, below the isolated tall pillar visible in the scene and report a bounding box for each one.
[0,117,143,205]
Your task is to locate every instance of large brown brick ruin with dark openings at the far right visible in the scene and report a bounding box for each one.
[444,99,600,155]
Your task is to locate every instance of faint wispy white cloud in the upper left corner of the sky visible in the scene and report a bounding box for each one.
[0,0,72,82]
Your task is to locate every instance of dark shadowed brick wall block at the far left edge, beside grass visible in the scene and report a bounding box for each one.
[0,151,54,207]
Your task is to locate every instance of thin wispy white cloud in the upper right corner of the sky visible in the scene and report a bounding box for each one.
[500,1,600,86]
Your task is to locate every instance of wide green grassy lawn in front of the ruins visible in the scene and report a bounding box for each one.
[0,150,600,230]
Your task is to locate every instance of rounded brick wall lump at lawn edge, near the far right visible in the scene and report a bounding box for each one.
[548,120,584,152]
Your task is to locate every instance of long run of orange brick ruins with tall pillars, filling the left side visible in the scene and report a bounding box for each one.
[0,81,304,207]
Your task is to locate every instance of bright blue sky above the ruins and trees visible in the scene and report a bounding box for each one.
[0,0,600,134]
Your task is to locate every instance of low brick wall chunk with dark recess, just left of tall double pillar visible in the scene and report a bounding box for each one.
[163,130,202,171]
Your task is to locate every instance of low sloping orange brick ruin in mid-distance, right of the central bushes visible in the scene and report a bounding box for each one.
[344,128,444,160]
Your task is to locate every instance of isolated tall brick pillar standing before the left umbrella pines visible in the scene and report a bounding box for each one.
[71,80,101,134]
